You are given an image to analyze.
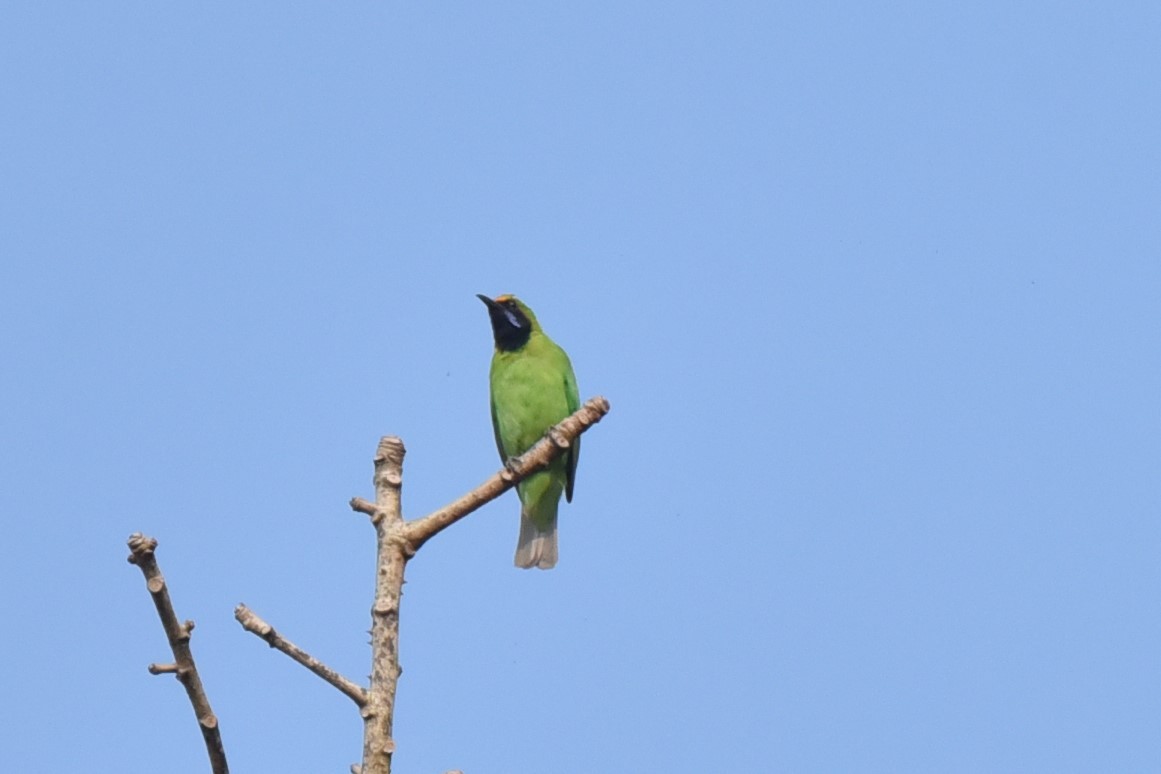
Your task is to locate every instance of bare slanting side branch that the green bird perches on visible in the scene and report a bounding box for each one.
[405,396,608,550]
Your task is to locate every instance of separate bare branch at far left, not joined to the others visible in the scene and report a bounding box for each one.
[129,533,230,774]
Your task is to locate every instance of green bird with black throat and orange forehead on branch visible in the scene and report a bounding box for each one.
[477,296,581,570]
